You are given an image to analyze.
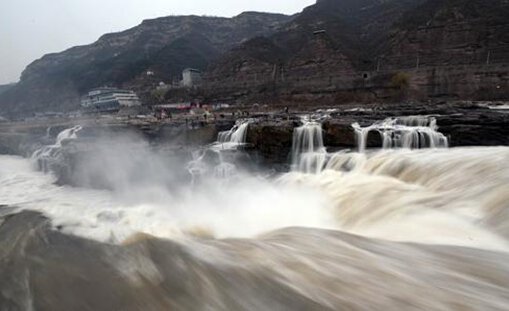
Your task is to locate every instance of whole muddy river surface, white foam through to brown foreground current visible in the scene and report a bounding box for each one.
[0,147,509,310]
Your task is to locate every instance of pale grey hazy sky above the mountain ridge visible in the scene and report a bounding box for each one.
[0,0,316,84]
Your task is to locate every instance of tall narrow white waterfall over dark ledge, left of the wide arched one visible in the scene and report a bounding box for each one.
[292,122,327,174]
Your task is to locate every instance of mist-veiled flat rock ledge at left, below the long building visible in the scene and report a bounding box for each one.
[0,119,235,157]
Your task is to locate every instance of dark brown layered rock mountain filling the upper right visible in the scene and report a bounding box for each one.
[201,0,509,102]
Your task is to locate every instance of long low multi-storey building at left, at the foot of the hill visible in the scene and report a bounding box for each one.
[81,87,141,111]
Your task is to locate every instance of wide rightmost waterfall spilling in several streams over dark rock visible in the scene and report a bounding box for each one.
[352,116,449,152]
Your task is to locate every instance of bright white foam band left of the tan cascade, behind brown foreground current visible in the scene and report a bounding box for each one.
[0,156,334,242]
